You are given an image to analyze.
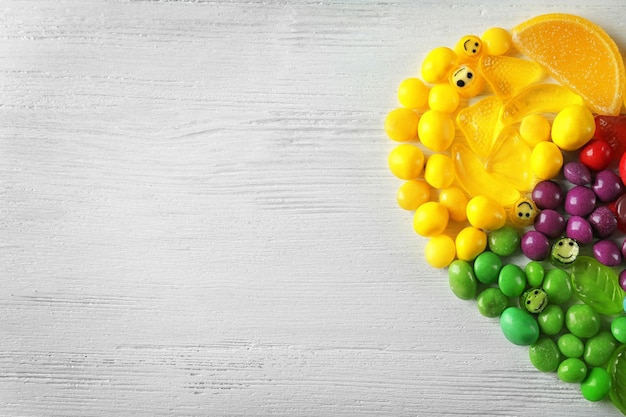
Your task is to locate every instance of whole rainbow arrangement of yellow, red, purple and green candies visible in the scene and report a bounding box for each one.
[385,14,626,415]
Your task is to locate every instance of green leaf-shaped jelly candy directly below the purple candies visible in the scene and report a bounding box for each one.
[571,256,625,315]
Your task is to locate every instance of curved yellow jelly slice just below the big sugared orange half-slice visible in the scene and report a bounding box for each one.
[500,83,583,125]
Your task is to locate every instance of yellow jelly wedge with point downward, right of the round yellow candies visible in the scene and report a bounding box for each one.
[456,96,502,158]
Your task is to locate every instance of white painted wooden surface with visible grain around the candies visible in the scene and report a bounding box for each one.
[0,0,626,417]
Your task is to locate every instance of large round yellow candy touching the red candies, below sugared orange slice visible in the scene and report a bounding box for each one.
[552,104,596,151]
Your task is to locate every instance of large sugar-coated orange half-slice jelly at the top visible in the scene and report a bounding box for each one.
[512,13,626,115]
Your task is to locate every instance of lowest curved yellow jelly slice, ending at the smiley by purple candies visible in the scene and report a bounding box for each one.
[451,143,521,207]
